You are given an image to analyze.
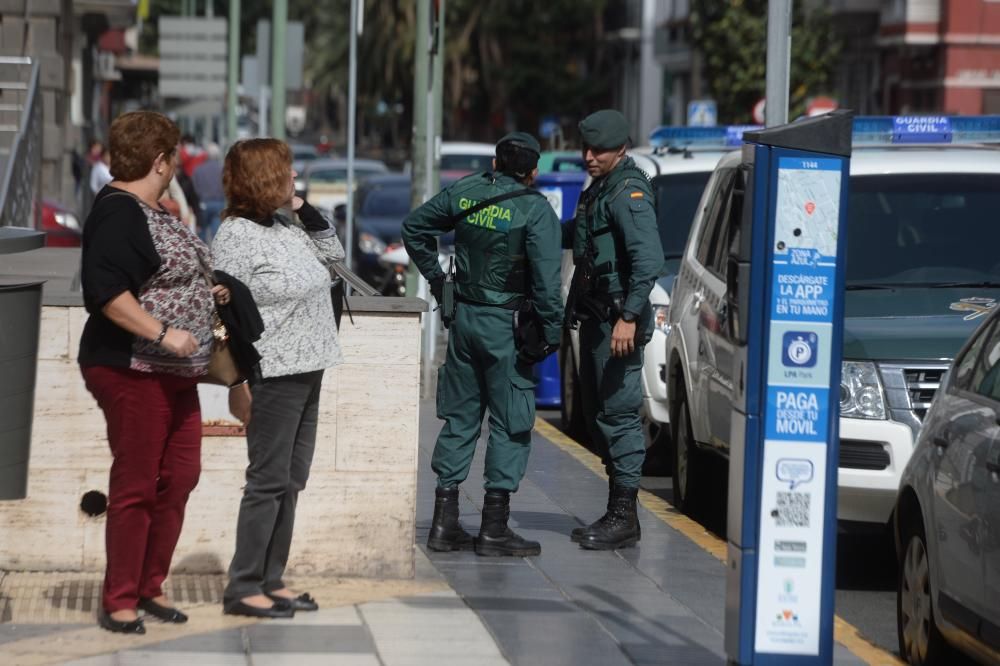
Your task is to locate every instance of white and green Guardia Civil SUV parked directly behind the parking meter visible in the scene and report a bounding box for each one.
[666,118,1000,528]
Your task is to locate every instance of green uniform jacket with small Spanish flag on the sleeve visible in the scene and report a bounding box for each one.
[563,157,663,319]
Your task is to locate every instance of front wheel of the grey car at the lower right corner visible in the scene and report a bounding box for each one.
[896,516,950,666]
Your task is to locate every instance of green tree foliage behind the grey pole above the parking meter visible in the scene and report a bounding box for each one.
[690,0,841,123]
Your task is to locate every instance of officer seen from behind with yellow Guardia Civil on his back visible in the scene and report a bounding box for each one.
[403,132,563,556]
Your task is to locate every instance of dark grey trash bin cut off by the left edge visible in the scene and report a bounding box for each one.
[0,227,45,500]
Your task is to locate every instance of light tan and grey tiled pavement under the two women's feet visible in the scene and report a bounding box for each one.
[0,550,508,666]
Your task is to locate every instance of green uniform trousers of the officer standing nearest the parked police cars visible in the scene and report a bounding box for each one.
[580,320,646,488]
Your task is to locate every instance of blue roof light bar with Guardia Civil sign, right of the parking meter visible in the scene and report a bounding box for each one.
[852,116,1000,146]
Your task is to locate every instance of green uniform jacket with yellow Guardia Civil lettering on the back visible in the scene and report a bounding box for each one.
[403,173,563,344]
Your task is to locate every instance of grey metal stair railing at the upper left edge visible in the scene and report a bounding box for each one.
[0,57,42,229]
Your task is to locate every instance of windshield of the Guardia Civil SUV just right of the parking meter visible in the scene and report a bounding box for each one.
[847,173,1000,287]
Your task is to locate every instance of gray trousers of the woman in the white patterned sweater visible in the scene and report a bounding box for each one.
[223,370,323,603]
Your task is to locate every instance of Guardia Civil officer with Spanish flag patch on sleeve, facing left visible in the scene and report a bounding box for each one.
[563,109,663,550]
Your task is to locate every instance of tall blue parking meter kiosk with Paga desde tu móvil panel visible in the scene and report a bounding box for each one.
[726,112,851,664]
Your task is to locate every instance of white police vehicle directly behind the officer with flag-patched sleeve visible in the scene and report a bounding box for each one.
[559,127,739,456]
